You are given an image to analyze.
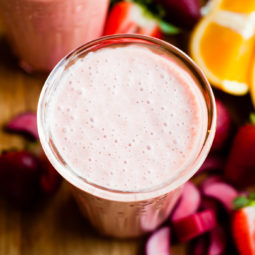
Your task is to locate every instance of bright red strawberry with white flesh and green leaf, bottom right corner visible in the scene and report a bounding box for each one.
[232,195,255,255]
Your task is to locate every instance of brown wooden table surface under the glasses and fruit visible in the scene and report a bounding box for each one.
[0,22,252,255]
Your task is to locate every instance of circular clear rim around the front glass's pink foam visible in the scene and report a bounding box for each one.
[37,34,216,201]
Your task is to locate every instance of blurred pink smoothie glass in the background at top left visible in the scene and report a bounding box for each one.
[0,0,109,72]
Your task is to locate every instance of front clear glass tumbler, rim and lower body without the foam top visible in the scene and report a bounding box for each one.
[38,35,216,237]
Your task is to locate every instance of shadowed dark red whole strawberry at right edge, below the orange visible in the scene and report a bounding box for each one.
[225,115,255,187]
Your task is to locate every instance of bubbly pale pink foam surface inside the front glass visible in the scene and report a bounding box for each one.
[49,44,207,191]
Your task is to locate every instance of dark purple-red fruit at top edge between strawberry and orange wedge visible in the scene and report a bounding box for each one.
[157,0,201,28]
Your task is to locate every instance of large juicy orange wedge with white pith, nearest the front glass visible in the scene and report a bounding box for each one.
[190,0,255,95]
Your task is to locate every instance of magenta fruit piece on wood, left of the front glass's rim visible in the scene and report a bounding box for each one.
[6,112,39,139]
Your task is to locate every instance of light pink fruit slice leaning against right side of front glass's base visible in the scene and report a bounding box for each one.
[171,182,201,221]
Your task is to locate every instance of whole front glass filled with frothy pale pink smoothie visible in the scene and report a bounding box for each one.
[38,36,215,237]
